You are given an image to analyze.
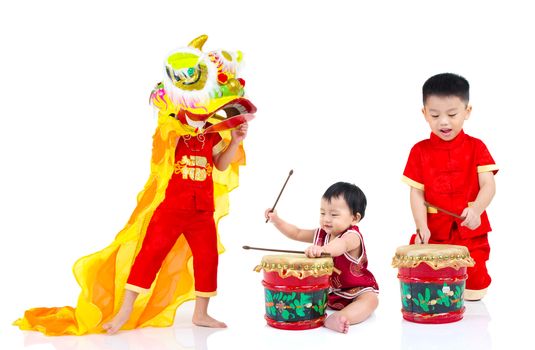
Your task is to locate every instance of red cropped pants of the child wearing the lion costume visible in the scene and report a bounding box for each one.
[127,207,219,294]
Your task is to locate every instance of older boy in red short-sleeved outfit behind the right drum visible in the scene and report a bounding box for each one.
[403,73,498,300]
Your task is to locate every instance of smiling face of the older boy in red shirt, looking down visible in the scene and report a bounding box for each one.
[422,95,472,141]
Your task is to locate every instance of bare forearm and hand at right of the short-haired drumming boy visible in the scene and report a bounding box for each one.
[461,171,496,230]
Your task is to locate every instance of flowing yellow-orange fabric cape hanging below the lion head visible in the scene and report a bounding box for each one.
[14,105,245,335]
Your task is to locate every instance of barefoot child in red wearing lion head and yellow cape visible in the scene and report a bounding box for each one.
[15,35,256,335]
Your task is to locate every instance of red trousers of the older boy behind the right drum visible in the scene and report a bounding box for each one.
[410,224,491,290]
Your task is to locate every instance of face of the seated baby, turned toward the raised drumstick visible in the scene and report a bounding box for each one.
[320,196,360,236]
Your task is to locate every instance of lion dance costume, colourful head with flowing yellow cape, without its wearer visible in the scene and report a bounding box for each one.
[15,35,256,335]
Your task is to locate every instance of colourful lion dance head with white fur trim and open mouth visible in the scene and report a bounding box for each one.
[150,35,256,129]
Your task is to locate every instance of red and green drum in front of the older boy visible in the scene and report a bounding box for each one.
[392,244,474,323]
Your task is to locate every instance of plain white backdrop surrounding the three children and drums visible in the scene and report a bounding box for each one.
[0,0,535,349]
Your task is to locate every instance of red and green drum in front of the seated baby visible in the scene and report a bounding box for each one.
[255,254,333,330]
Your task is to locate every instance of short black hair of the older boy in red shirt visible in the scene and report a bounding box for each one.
[422,73,470,105]
